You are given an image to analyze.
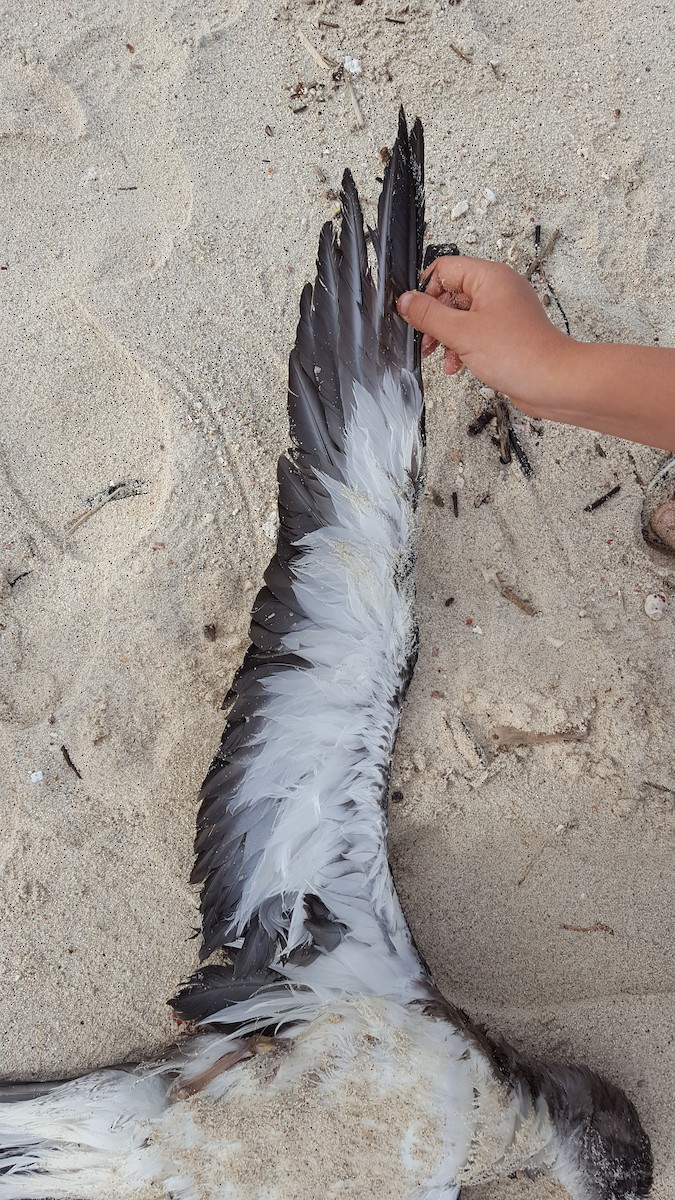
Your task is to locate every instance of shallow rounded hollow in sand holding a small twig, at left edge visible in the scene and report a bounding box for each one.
[0,304,171,725]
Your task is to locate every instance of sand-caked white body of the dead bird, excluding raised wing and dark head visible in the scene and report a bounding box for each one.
[0,996,552,1200]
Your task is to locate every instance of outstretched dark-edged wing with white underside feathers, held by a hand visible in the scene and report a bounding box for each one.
[172,110,425,1019]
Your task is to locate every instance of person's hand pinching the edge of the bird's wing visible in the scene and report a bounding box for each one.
[398,256,571,416]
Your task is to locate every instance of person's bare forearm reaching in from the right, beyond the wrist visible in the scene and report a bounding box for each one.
[528,340,675,452]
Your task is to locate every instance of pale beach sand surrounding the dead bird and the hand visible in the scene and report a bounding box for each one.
[0,0,675,1200]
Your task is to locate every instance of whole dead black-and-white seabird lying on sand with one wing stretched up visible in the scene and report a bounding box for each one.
[0,113,652,1200]
